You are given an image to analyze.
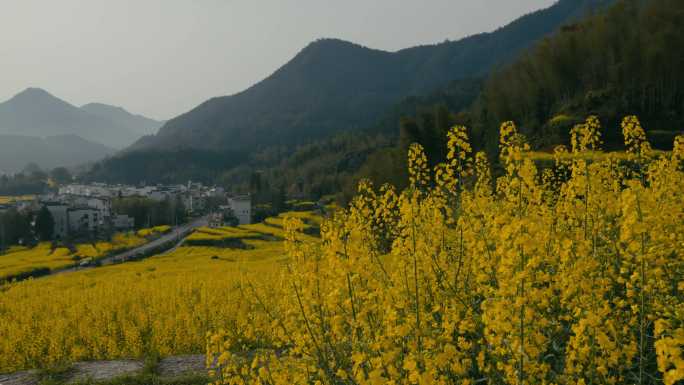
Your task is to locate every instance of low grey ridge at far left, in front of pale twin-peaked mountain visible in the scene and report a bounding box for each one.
[0,134,116,174]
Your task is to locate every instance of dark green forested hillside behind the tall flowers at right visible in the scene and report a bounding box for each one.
[472,0,684,154]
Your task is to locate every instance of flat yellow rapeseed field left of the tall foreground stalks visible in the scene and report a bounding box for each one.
[0,213,315,372]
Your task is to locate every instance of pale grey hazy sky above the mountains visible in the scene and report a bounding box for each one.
[0,0,554,119]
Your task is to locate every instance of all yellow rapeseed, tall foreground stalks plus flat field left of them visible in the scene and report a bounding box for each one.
[0,116,684,385]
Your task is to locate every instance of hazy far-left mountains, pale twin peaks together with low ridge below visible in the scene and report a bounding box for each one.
[0,88,163,172]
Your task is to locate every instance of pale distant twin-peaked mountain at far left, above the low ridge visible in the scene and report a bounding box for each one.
[0,88,161,148]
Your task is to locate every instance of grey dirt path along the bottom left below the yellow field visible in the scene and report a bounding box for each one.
[0,354,207,385]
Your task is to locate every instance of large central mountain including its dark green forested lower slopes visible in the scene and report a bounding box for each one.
[88,0,616,186]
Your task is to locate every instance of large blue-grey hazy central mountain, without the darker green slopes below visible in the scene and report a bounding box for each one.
[129,0,612,151]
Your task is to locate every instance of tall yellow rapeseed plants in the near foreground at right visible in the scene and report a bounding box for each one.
[207,117,684,385]
